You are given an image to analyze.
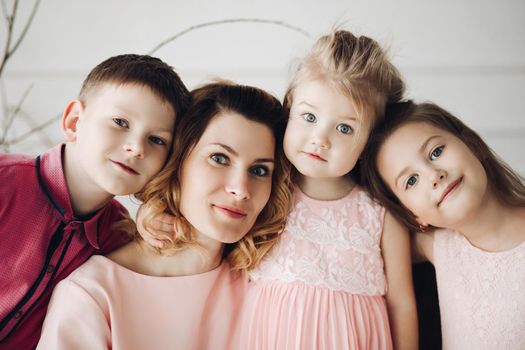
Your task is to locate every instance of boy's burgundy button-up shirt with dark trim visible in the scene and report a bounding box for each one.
[0,145,126,349]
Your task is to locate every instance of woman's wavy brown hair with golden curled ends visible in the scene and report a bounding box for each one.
[136,81,292,270]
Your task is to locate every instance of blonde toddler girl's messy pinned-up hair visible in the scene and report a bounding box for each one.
[284,30,405,180]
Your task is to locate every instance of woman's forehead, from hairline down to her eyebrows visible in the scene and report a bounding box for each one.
[193,111,275,152]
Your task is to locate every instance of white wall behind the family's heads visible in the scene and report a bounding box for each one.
[0,0,525,216]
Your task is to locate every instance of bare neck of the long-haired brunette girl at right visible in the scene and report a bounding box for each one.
[451,198,525,252]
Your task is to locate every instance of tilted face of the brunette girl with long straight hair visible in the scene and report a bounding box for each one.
[377,122,488,228]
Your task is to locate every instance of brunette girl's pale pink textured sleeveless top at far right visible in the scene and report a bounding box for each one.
[433,230,525,350]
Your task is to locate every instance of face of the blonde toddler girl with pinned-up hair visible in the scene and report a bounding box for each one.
[284,80,369,178]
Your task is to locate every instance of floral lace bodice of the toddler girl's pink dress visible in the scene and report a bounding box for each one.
[250,186,386,295]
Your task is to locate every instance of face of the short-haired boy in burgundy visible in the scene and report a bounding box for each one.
[69,83,175,195]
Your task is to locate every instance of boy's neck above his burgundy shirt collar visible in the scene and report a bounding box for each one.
[62,144,114,216]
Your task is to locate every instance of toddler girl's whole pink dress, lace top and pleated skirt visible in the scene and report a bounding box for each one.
[241,186,392,350]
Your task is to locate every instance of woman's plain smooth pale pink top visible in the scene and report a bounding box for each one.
[37,256,248,350]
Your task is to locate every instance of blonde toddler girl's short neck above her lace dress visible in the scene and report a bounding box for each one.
[297,175,355,201]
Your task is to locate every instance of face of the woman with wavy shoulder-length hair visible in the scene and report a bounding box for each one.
[180,112,275,243]
